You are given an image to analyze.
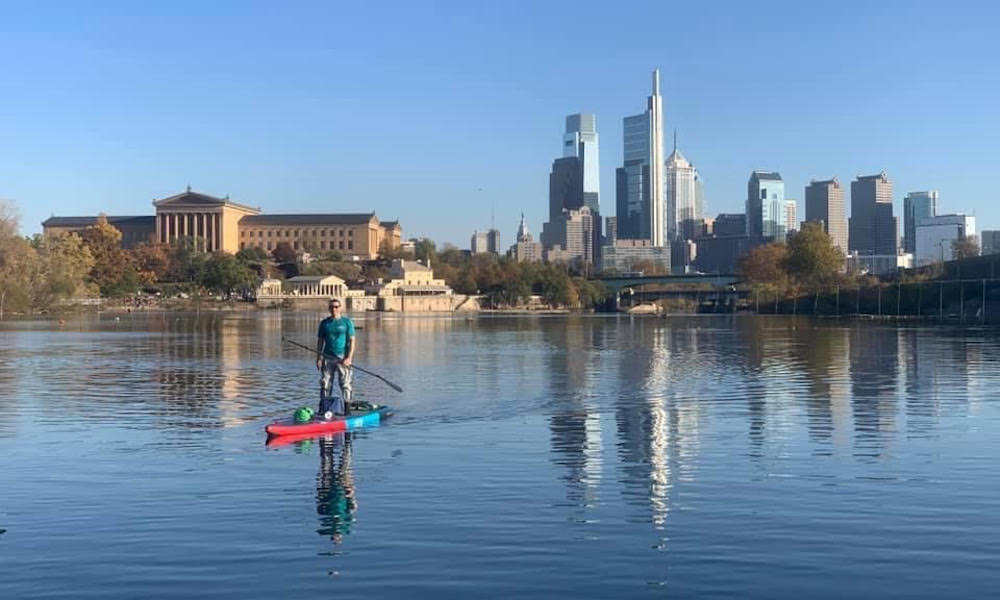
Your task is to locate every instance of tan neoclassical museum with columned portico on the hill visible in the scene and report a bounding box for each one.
[42,187,402,259]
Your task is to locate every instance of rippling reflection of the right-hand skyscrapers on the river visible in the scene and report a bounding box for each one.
[545,318,982,528]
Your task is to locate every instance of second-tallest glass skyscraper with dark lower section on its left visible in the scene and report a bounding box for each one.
[543,114,601,262]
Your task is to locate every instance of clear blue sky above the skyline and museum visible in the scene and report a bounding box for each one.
[0,1,1000,247]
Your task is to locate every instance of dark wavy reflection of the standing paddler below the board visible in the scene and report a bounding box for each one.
[316,433,358,544]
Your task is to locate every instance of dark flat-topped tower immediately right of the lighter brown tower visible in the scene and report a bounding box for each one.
[847,171,899,256]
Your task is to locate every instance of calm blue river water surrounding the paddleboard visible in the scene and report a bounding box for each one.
[0,312,1000,600]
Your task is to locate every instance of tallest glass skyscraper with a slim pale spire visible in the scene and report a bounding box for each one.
[615,69,667,246]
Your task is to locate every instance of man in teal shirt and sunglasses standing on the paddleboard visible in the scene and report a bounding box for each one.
[316,298,355,420]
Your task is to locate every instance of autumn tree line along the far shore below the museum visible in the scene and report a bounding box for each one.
[0,202,608,318]
